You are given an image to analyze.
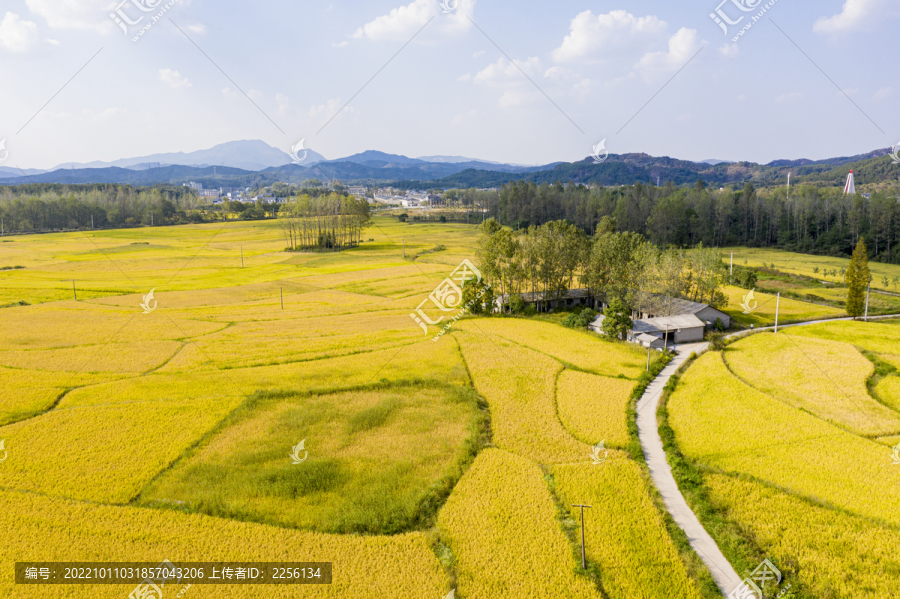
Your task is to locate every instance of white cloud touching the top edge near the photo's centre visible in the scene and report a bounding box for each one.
[353,0,475,41]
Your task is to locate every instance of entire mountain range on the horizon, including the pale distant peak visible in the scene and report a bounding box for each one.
[0,140,900,189]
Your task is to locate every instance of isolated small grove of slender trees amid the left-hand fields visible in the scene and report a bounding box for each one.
[278,193,372,251]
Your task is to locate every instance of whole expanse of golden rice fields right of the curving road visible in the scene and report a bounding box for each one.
[667,321,900,599]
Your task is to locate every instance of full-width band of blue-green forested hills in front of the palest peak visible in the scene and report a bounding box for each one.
[0,148,900,189]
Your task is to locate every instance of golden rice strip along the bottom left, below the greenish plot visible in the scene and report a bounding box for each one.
[0,490,450,599]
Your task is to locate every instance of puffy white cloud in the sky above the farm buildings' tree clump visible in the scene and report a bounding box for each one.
[552,10,667,62]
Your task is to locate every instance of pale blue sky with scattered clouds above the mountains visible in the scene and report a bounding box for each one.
[0,0,900,168]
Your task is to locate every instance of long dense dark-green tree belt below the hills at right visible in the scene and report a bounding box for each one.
[485,181,900,263]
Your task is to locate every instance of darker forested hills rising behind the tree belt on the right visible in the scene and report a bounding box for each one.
[397,148,900,189]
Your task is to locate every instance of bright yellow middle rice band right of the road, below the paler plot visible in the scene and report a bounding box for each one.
[668,353,900,525]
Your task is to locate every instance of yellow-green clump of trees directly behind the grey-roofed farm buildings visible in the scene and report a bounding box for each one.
[478,217,728,315]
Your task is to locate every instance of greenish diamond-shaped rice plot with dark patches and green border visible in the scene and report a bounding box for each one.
[141,386,480,534]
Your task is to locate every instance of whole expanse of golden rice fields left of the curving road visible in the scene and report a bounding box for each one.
[0,217,713,599]
